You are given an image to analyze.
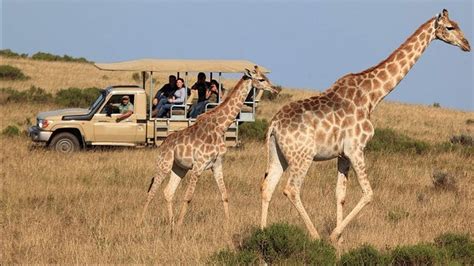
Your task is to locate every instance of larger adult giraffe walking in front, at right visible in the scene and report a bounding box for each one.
[261,10,470,244]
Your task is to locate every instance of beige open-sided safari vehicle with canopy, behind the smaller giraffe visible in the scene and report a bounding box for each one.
[28,59,269,153]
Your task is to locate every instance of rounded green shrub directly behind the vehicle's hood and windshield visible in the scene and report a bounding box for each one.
[55,87,100,108]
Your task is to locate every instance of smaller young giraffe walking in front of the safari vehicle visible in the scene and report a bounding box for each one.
[140,66,276,227]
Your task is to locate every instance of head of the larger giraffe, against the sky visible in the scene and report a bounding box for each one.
[435,9,471,52]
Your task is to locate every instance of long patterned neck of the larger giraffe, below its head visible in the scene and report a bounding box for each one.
[356,18,436,112]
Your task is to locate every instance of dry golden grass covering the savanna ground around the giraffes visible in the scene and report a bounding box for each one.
[0,58,474,264]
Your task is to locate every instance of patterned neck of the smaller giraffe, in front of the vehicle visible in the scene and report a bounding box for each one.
[209,78,252,133]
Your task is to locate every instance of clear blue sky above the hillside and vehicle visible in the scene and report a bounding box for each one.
[0,0,474,111]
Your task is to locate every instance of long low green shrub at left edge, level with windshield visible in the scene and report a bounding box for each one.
[1,86,53,103]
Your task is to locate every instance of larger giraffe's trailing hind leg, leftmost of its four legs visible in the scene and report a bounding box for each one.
[260,136,287,229]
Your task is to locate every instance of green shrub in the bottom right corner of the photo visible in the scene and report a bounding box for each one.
[434,233,474,265]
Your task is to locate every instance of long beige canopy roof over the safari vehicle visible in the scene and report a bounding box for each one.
[95,59,270,73]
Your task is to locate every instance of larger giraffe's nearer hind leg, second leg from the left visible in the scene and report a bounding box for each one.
[283,158,320,239]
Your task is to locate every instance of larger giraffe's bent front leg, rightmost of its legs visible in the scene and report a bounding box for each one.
[330,149,373,243]
